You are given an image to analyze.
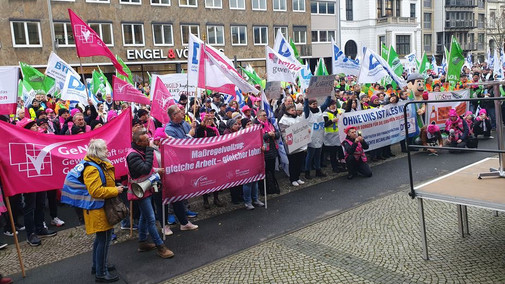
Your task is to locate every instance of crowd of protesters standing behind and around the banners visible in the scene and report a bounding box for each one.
[0,61,505,280]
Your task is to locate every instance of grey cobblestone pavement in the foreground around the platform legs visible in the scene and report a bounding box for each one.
[165,191,505,283]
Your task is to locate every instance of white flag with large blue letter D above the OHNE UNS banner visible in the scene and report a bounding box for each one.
[358,48,407,88]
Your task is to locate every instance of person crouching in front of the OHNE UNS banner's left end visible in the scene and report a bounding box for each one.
[342,125,372,179]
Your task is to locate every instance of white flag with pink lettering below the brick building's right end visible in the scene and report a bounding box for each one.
[265,46,302,83]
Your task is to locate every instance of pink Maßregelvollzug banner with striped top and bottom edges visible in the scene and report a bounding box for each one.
[161,125,265,203]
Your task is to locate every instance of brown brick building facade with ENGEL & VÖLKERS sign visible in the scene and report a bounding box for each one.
[0,0,311,82]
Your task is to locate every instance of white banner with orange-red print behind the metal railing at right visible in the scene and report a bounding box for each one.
[425,90,470,129]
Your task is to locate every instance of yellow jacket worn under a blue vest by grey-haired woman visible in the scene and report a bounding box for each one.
[82,156,118,235]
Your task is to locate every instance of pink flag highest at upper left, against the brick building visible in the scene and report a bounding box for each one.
[68,9,128,76]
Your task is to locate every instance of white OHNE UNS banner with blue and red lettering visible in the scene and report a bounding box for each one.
[338,102,416,151]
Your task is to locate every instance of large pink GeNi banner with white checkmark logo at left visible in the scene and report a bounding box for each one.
[0,109,132,196]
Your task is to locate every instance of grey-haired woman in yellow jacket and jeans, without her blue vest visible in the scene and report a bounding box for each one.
[83,139,123,282]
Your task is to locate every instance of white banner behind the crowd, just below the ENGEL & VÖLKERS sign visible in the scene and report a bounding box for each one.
[151,73,202,101]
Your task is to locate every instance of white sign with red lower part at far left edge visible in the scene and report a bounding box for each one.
[0,66,19,115]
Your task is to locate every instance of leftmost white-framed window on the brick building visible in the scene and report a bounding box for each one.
[11,21,42,47]
